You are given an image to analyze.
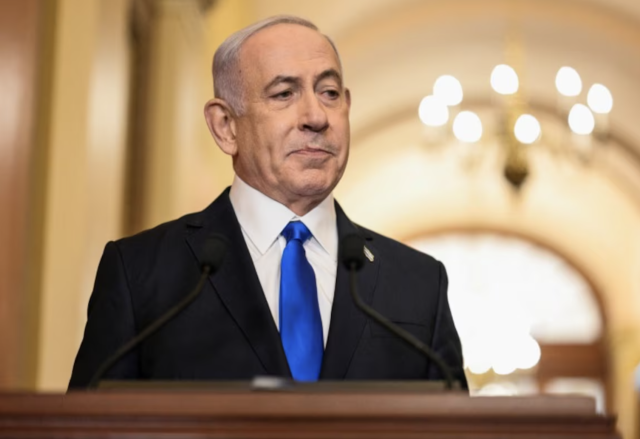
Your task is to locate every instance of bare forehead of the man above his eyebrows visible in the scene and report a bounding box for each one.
[239,24,340,80]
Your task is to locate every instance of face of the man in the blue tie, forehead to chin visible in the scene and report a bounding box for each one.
[234,24,350,214]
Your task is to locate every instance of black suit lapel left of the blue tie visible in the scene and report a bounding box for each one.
[187,190,291,377]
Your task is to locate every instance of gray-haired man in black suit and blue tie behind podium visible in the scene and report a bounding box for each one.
[69,17,466,388]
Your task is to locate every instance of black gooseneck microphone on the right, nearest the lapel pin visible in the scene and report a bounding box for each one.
[340,234,454,390]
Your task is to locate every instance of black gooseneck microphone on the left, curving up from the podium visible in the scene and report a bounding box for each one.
[87,234,229,389]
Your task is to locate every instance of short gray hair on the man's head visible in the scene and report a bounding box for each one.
[211,15,342,115]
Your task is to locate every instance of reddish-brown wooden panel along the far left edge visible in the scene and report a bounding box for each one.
[0,0,41,388]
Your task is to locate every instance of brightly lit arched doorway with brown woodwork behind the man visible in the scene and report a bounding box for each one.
[409,231,610,412]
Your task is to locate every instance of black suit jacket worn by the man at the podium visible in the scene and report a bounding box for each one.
[69,189,466,388]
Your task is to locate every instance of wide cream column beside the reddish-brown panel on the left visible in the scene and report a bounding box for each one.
[37,0,129,390]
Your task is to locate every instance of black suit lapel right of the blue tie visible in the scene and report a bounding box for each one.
[320,203,380,380]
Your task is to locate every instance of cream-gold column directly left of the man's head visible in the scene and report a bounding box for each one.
[143,0,215,228]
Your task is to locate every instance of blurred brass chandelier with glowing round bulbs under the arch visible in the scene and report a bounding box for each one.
[418,38,613,191]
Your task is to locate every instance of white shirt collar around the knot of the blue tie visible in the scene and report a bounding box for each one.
[229,175,338,261]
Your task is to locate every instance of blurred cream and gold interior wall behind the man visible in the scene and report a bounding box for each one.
[0,0,640,438]
